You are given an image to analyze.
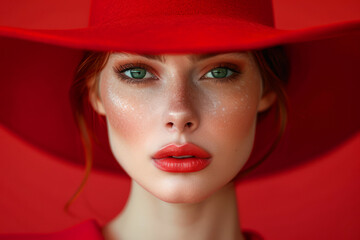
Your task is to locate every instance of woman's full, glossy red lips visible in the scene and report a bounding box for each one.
[153,143,211,172]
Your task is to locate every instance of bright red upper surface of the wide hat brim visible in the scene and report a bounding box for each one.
[0,15,360,53]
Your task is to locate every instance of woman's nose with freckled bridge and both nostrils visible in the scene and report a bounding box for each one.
[164,82,199,133]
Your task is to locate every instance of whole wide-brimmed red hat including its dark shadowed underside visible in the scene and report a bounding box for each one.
[0,0,360,238]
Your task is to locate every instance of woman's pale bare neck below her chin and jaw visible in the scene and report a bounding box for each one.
[103,181,244,240]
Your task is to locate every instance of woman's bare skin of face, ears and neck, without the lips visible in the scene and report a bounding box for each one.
[90,52,275,240]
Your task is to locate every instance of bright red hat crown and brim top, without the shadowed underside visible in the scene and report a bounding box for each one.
[0,0,360,53]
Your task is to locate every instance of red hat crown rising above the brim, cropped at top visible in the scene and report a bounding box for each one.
[90,0,274,26]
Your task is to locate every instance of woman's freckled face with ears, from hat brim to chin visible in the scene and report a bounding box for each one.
[90,52,274,203]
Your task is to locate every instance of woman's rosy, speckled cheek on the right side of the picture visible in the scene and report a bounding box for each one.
[200,81,260,175]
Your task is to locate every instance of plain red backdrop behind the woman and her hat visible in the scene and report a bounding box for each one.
[0,0,360,239]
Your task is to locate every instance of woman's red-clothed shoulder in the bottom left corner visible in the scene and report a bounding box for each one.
[0,220,104,240]
